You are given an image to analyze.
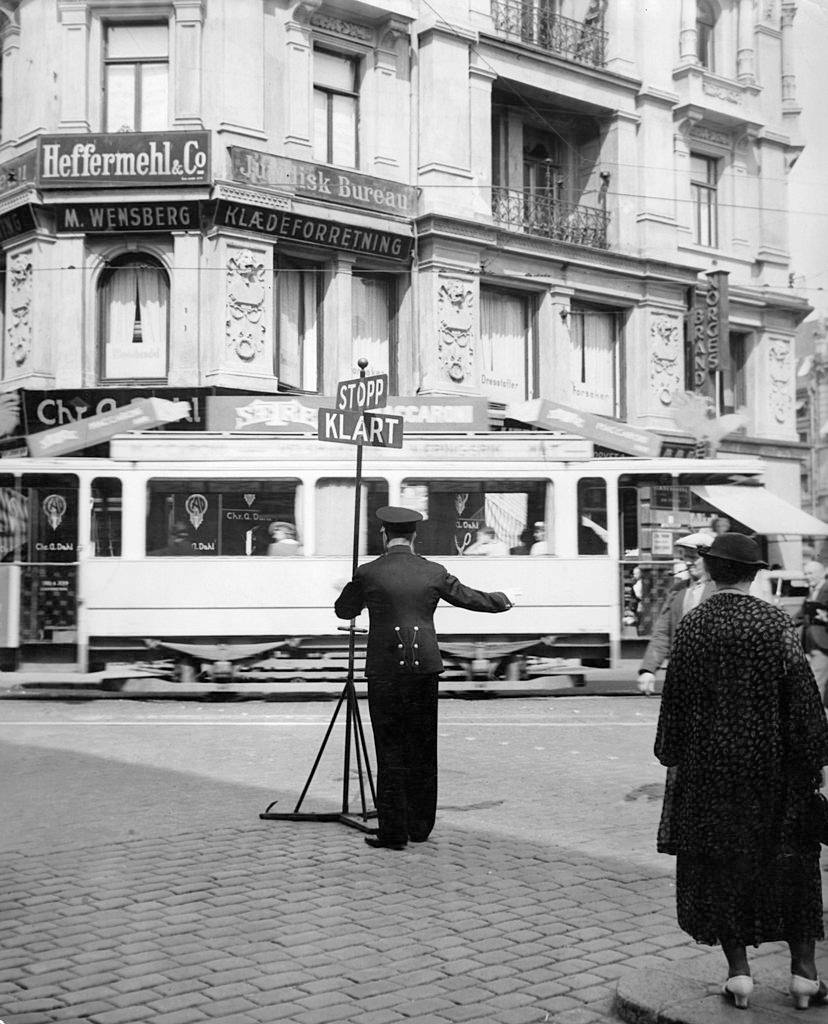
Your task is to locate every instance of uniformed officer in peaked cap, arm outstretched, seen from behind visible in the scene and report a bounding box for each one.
[334,506,517,850]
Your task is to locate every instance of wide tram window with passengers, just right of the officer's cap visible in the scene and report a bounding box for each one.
[402,479,555,556]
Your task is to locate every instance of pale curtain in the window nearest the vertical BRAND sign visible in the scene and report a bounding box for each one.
[569,309,617,416]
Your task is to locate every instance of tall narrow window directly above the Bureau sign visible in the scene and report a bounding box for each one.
[313,48,359,167]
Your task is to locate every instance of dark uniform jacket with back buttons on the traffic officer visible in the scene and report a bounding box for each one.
[334,544,512,676]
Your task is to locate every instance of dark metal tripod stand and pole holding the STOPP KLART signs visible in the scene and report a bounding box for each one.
[259,358,377,833]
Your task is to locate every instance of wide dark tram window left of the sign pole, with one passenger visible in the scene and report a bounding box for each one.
[146,479,304,557]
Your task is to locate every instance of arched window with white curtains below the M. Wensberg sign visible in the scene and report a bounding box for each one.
[99,253,170,381]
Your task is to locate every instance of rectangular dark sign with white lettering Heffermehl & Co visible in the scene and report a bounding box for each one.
[37,131,210,188]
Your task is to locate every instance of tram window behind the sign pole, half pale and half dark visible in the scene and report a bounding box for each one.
[316,478,388,555]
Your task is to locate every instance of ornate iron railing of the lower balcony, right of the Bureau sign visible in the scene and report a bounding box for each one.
[491,185,609,249]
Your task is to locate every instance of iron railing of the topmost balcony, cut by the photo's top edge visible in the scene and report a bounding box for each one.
[491,0,607,68]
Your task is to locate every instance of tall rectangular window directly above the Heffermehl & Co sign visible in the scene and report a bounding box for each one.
[103,23,170,132]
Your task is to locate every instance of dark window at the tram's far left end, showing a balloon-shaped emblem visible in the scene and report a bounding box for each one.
[21,473,78,562]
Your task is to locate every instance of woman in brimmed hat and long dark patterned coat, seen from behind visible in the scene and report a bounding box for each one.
[655,532,828,1009]
